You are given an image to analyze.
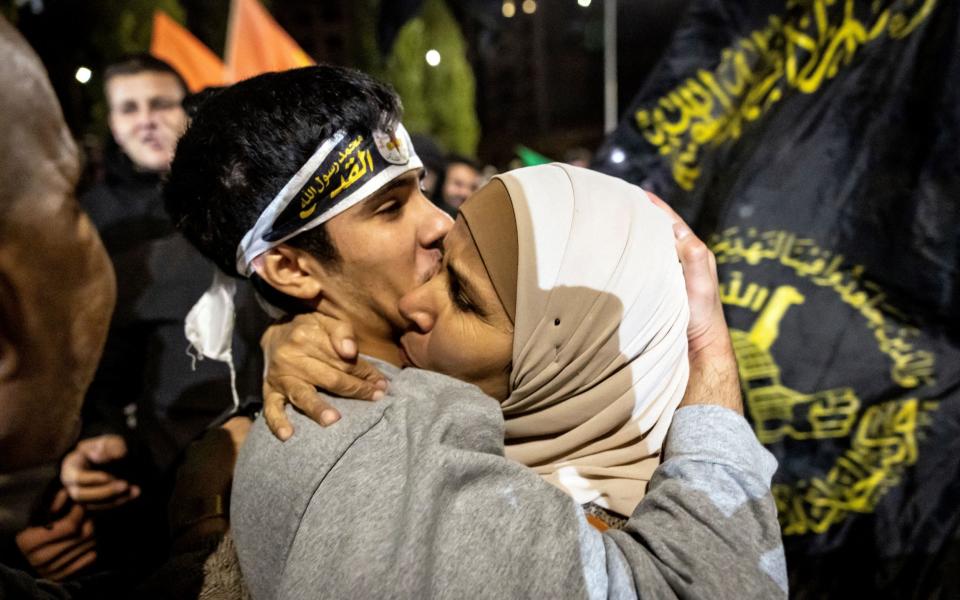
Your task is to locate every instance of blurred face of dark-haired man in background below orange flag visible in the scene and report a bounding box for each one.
[106,71,187,172]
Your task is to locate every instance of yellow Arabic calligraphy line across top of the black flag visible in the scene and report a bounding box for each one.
[634,0,938,191]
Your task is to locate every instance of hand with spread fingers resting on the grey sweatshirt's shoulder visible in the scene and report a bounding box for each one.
[260,313,387,441]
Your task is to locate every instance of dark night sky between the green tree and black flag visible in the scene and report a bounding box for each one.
[461,0,688,167]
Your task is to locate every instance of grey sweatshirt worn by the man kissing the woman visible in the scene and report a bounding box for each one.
[231,367,787,600]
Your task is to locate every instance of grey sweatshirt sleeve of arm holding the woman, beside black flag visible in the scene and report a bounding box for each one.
[605,406,787,598]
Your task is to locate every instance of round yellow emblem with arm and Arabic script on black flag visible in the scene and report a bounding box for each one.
[709,227,939,535]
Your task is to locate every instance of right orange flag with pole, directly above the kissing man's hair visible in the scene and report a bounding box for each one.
[226,0,316,81]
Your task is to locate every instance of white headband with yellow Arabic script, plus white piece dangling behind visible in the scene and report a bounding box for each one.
[184,124,423,409]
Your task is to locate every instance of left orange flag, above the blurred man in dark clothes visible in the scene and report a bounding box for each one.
[150,10,226,92]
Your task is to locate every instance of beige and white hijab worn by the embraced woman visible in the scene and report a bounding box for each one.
[462,164,689,515]
